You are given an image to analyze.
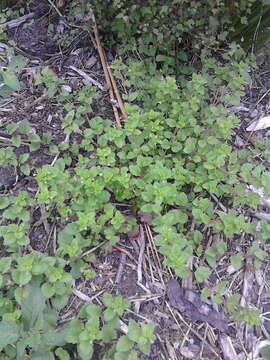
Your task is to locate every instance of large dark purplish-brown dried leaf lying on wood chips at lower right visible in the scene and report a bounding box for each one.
[167,280,229,333]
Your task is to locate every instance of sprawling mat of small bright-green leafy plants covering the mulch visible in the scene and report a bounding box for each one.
[0,0,270,360]
